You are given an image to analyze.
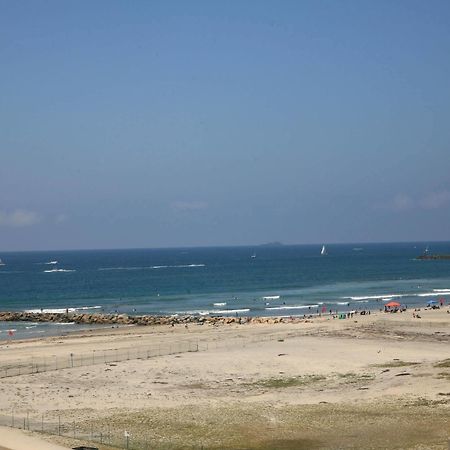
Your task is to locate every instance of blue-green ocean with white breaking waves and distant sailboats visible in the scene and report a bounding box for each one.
[0,242,450,339]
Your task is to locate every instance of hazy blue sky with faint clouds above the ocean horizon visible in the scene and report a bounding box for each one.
[0,0,450,251]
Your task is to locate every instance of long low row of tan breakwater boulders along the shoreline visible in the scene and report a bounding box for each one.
[0,311,305,325]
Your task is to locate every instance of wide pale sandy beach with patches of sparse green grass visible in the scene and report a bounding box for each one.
[0,307,450,450]
